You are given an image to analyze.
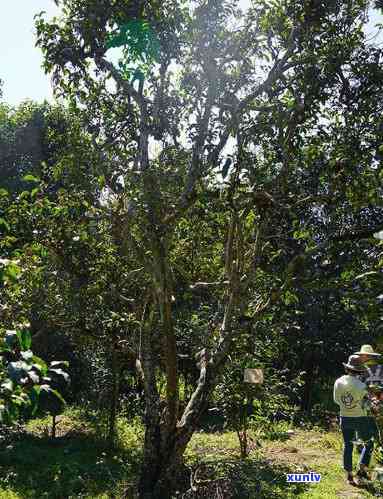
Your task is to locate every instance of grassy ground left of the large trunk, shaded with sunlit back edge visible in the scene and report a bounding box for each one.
[0,412,142,499]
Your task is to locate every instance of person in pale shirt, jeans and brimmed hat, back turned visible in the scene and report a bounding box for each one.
[334,355,376,485]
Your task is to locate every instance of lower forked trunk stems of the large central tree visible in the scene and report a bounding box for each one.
[139,213,255,499]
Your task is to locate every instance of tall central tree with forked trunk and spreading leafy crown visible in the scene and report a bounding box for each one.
[37,0,382,498]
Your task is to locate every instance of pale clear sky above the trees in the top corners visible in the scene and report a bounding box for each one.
[0,0,383,105]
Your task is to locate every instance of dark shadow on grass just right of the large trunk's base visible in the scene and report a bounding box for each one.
[183,458,309,499]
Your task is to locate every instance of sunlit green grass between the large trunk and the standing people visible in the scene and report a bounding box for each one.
[187,428,381,499]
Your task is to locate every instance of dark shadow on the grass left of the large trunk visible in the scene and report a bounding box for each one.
[0,433,140,499]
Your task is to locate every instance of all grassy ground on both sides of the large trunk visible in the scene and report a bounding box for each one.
[0,411,383,499]
